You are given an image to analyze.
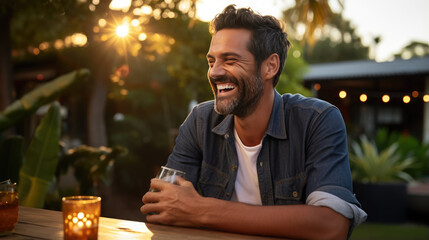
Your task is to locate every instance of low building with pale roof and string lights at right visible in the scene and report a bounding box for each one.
[304,56,429,142]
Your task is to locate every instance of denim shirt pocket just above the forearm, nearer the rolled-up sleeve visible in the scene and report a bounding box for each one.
[274,173,306,205]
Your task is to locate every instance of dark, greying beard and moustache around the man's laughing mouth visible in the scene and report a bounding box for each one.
[210,74,264,118]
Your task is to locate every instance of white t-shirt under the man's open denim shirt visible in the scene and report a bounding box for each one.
[231,128,262,205]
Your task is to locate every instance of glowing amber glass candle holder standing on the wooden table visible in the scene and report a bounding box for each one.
[62,196,101,240]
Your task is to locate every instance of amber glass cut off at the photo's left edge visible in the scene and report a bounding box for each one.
[0,180,18,236]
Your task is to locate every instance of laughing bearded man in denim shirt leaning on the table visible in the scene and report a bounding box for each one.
[141,5,366,239]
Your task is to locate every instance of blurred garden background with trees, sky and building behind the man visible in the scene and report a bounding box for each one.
[0,0,429,239]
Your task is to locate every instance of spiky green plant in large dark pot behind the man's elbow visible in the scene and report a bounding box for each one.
[349,136,414,222]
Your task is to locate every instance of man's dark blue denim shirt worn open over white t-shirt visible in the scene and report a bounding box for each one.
[167,92,360,207]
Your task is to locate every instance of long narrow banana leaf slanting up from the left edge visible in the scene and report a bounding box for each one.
[0,69,89,132]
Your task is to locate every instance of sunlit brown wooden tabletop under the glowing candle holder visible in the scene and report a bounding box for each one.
[5,206,284,240]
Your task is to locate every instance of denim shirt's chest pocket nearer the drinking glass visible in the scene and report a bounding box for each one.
[198,162,229,198]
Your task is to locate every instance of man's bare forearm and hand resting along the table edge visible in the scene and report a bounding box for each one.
[140,179,350,239]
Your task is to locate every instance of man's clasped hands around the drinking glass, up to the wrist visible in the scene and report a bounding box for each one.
[140,177,204,227]
